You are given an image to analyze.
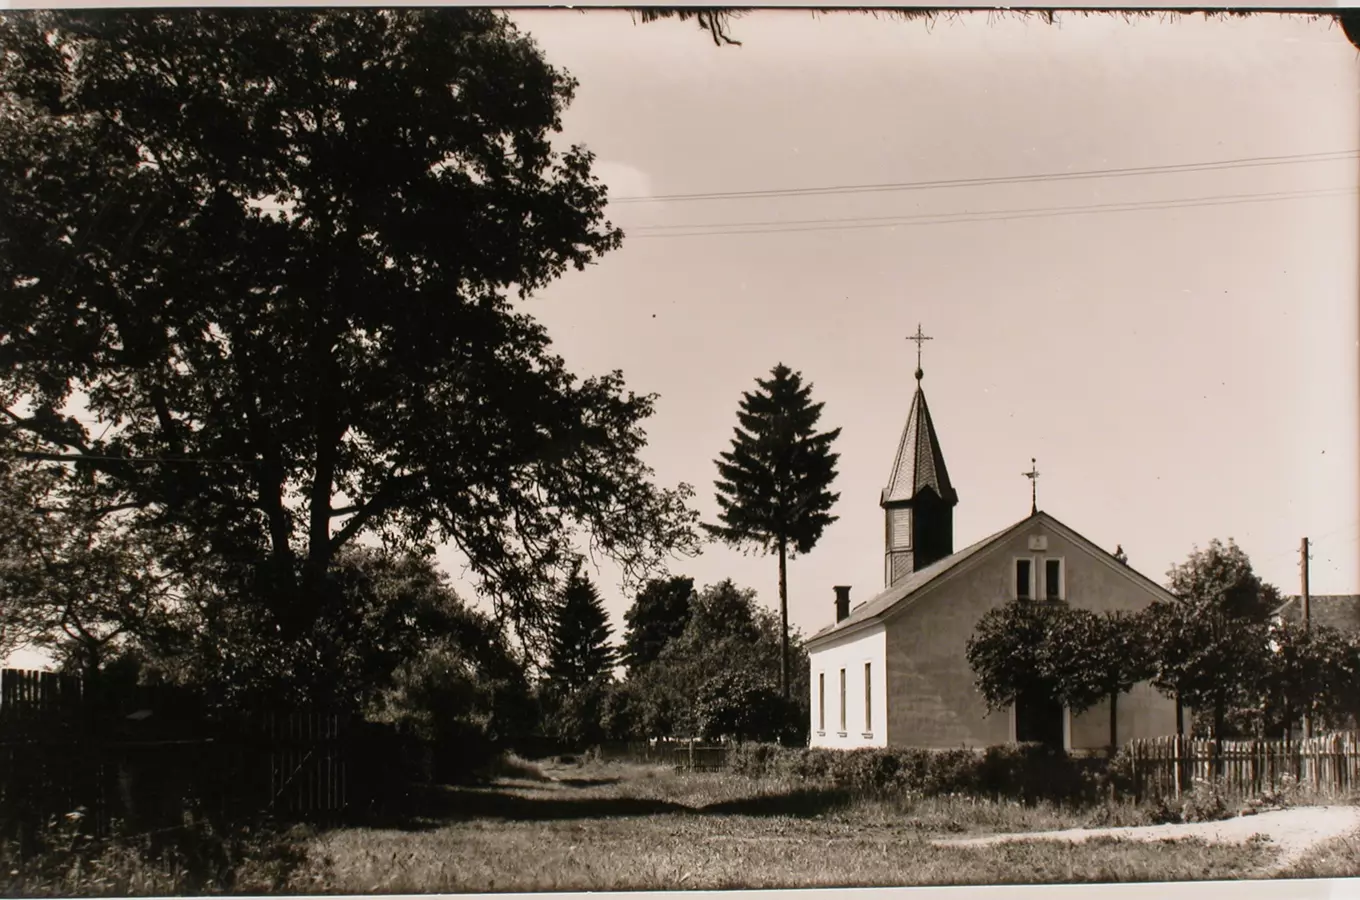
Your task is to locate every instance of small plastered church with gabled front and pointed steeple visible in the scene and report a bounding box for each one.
[806,329,1176,750]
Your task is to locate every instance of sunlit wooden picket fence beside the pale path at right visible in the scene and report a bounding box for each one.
[1126,731,1360,799]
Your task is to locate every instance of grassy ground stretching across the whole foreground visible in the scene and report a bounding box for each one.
[0,763,1360,897]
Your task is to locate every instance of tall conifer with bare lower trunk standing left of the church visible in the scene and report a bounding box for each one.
[704,363,840,697]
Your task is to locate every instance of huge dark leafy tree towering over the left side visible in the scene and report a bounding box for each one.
[0,8,694,696]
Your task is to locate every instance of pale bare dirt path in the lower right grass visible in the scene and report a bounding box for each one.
[932,806,1360,874]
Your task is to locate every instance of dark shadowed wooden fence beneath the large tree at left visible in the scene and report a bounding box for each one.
[0,669,362,833]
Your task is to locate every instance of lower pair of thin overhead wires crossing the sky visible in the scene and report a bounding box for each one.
[626,188,1357,241]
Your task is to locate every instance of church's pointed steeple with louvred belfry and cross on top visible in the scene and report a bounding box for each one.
[879,325,959,587]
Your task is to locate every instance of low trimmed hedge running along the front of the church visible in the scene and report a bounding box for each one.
[728,744,1107,803]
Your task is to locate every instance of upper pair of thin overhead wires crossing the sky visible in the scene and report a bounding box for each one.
[609,150,1360,204]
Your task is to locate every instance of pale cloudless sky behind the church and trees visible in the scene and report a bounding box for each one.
[429,11,1360,649]
